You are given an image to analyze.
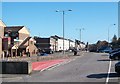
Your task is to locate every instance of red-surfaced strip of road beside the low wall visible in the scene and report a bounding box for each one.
[32,59,68,71]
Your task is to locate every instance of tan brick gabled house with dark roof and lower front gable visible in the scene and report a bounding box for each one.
[4,26,37,56]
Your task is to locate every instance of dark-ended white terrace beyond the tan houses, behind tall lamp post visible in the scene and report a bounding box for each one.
[34,35,75,52]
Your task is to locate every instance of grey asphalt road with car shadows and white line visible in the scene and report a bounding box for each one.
[3,52,120,84]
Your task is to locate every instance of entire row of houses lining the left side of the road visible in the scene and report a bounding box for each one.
[0,20,85,57]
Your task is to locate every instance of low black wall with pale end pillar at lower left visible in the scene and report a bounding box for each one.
[0,61,32,74]
